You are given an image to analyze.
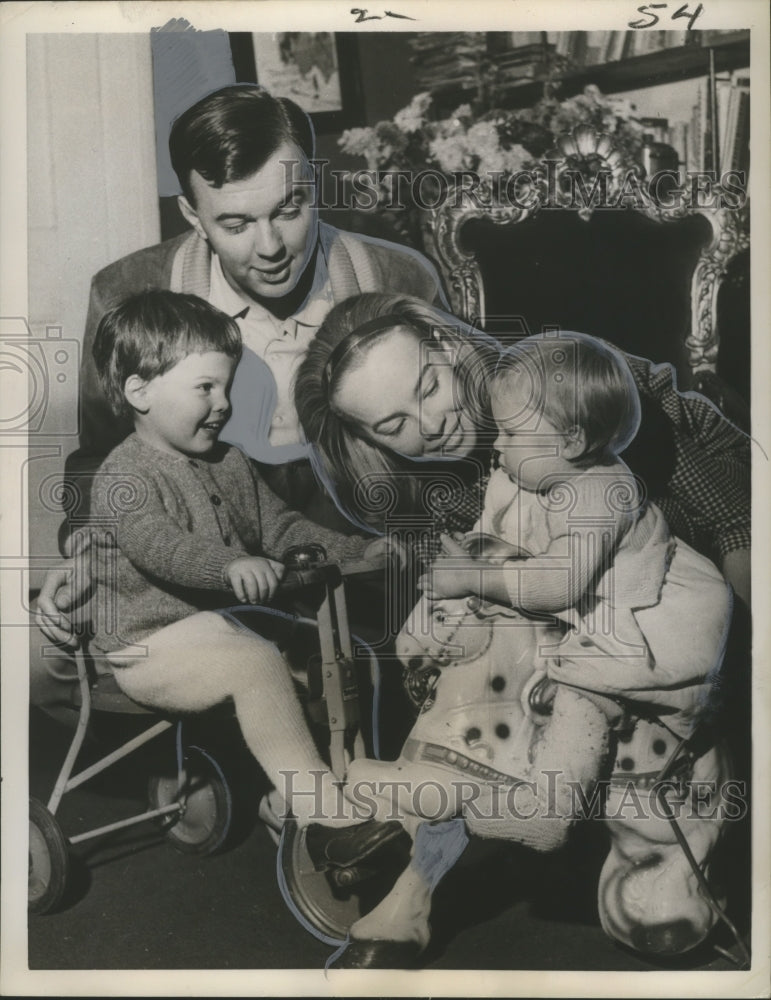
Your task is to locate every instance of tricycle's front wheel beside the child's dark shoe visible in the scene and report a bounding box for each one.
[278,819,409,944]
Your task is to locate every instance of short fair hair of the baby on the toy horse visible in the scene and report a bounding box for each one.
[491,331,640,466]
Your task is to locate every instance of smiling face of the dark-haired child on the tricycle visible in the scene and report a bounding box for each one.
[137,351,236,456]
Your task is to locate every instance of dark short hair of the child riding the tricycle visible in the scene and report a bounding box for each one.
[93,289,241,418]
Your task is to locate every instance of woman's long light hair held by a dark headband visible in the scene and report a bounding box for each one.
[294,292,500,529]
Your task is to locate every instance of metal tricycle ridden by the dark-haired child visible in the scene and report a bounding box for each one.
[28,546,402,937]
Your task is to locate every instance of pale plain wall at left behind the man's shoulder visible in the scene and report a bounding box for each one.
[27,34,160,585]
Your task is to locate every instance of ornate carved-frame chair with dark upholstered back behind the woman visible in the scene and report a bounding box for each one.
[422,126,749,428]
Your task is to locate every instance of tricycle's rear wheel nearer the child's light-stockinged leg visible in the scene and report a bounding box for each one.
[148,747,233,855]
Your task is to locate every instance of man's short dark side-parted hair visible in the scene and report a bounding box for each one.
[169,84,314,205]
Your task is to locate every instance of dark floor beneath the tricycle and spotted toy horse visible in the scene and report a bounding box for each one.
[29,713,747,971]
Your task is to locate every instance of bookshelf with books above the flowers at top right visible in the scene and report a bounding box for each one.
[411,30,750,178]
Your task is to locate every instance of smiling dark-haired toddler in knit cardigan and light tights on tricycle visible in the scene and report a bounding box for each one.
[91,291,398,840]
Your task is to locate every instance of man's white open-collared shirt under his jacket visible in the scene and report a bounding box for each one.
[209,244,334,465]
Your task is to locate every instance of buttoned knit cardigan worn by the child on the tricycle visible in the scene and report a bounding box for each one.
[91,434,367,653]
